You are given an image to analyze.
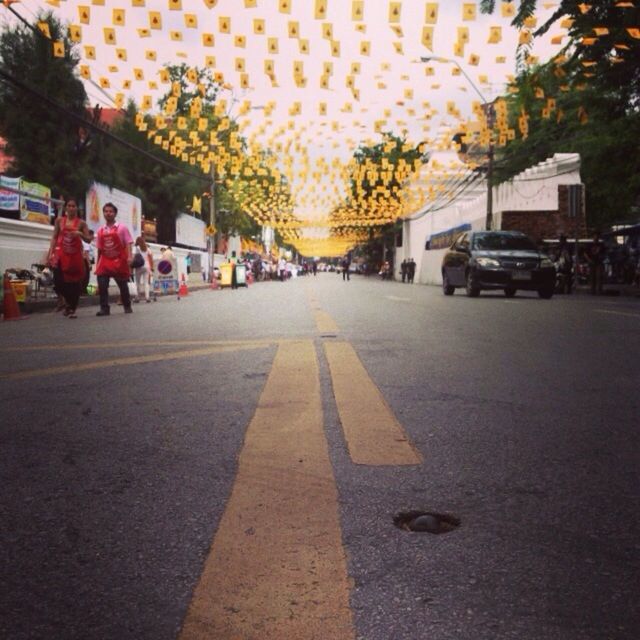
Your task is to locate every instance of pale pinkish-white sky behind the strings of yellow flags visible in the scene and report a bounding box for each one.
[0,0,566,230]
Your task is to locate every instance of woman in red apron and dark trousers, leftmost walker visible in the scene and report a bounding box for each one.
[48,198,93,318]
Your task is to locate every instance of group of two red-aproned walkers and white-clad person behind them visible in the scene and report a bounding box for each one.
[47,198,153,319]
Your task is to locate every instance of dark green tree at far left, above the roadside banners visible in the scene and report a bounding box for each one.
[0,13,113,197]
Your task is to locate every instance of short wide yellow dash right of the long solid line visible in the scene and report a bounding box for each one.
[324,342,422,465]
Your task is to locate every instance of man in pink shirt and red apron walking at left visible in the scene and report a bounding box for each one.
[96,202,133,316]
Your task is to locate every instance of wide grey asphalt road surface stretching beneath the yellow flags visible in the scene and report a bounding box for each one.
[0,274,640,640]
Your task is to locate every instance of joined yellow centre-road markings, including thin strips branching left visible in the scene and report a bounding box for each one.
[6,300,422,640]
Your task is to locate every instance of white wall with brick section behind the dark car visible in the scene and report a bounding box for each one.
[395,153,585,285]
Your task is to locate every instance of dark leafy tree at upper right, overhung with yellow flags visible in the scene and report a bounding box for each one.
[482,0,640,227]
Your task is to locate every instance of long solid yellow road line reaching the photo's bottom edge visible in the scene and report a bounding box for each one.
[180,341,355,640]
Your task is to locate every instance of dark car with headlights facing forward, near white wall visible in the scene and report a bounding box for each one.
[442,231,556,298]
